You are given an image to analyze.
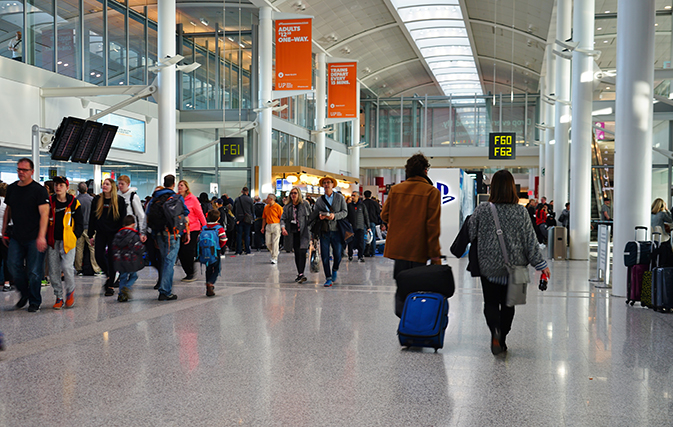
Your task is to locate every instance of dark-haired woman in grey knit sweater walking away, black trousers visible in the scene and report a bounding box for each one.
[469,170,549,354]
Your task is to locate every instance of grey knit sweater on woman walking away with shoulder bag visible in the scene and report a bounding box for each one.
[469,203,547,278]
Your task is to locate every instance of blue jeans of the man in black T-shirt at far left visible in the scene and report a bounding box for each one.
[7,239,44,307]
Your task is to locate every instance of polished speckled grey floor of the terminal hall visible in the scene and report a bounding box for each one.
[0,253,673,427]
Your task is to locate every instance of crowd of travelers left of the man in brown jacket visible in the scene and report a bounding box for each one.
[0,158,385,328]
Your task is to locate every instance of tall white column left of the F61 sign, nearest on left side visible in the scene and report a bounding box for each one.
[157,0,177,184]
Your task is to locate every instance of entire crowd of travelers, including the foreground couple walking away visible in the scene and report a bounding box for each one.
[0,153,552,354]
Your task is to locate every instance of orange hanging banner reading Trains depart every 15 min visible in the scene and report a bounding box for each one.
[327,62,358,119]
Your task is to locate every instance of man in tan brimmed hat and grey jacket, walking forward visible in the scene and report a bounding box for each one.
[309,176,348,287]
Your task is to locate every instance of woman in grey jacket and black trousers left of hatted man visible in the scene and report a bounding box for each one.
[280,187,311,283]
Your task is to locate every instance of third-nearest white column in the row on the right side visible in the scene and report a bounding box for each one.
[547,0,573,212]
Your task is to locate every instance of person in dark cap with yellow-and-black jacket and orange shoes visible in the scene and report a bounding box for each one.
[47,176,84,310]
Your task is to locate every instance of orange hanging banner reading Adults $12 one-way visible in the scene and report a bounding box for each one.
[275,18,313,90]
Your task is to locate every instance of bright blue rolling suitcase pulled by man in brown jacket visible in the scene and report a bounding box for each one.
[397,292,449,351]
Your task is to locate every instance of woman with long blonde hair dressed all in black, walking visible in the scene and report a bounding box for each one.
[89,178,126,297]
